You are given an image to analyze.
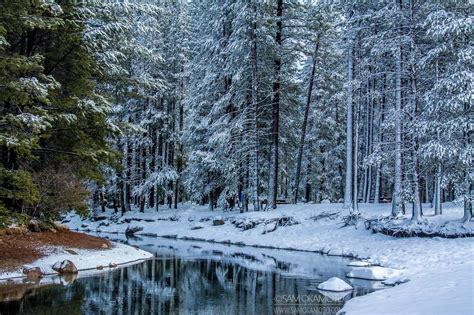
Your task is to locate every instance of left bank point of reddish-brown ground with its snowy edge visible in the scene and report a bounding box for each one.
[0,230,152,281]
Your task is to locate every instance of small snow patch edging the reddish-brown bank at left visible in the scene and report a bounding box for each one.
[0,243,153,282]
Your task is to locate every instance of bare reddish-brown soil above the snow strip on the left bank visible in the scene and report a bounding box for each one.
[0,230,110,272]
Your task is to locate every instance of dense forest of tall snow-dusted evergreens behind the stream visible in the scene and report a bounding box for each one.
[0,0,474,225]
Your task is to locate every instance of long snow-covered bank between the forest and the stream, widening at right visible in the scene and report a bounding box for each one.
[66,204,474,315]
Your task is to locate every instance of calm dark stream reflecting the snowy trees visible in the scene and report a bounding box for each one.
[0,238,381,315]
